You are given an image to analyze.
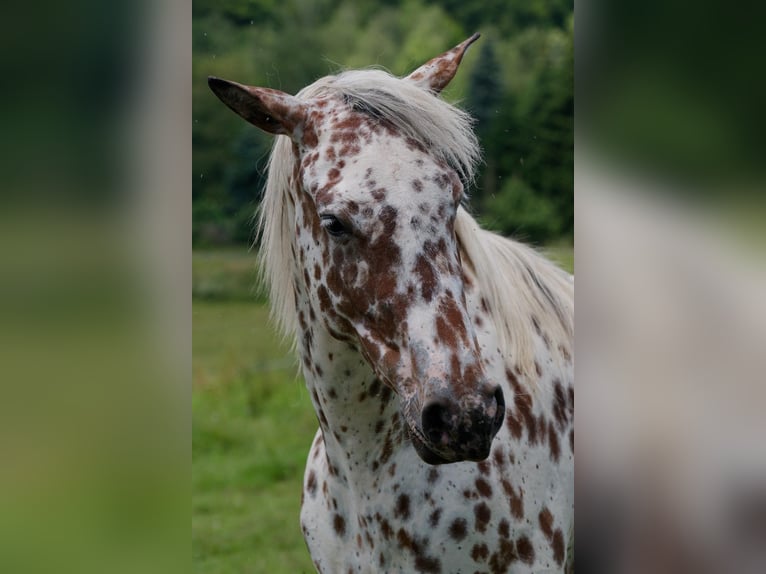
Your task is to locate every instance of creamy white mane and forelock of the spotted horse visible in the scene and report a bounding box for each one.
[258,70,574,380]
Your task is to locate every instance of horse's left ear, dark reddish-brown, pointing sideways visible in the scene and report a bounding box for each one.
[207,76,306,141]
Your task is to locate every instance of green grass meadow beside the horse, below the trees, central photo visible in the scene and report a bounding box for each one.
[192,246,573,574]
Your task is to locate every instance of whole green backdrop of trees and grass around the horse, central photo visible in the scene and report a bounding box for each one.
[192,0,574,574]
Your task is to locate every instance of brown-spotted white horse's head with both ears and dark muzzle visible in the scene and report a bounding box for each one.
[209,35,505,464]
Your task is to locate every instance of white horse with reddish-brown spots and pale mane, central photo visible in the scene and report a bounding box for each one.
[208,34,574,574]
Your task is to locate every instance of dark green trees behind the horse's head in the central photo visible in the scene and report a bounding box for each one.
[192,0,574,247]
